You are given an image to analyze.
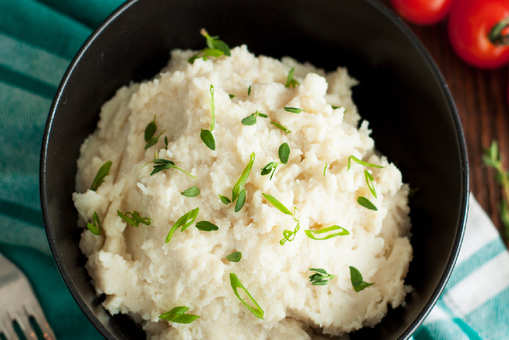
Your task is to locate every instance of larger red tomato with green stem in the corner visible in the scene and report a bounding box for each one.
[449,0,509,68]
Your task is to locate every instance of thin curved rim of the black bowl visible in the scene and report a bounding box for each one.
[39,0,470,340]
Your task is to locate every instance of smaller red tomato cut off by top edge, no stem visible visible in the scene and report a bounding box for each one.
[391,0,452,25]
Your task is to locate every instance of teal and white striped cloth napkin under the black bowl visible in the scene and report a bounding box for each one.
[0,0,509,340]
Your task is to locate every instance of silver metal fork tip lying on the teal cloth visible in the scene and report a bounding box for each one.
[0,254,56,340]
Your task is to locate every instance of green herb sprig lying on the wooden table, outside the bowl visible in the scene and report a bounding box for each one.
[483,141,509,238]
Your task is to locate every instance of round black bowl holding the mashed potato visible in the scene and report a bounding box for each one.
[40,0,468,339]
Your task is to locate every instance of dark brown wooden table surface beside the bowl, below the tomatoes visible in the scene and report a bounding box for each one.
[411,22,509,245]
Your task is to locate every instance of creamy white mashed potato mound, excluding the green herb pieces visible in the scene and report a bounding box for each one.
[73,46,412,340]
